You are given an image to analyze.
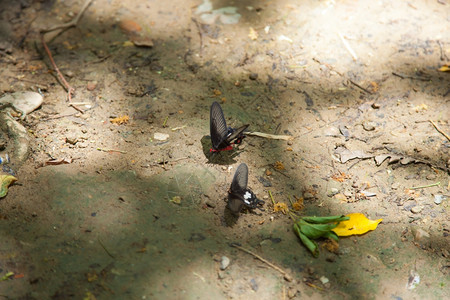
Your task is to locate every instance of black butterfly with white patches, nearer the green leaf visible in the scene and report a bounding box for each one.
[227,164,265,215]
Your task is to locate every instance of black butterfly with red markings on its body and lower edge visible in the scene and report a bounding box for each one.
[209,102,249,152]
